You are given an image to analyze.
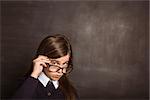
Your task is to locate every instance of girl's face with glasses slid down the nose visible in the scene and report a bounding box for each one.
[44,54,69,81]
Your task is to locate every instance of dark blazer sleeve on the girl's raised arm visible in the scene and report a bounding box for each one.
[13,76,38,99]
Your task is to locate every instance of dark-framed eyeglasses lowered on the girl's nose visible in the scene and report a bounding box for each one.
[46,63,73,74]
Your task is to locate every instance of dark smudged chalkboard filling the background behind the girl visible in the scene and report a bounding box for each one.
[1,1,149,100]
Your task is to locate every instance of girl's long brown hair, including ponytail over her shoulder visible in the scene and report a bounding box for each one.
[36,34,77,100]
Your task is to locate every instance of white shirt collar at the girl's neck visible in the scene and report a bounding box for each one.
[38,72,59,89]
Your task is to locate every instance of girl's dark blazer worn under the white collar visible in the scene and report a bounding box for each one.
[13,76,65,100]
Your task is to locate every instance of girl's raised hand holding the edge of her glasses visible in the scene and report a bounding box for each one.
[31,55,50,78]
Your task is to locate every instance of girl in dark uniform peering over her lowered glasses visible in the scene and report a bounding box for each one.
[14,35,77,100]
